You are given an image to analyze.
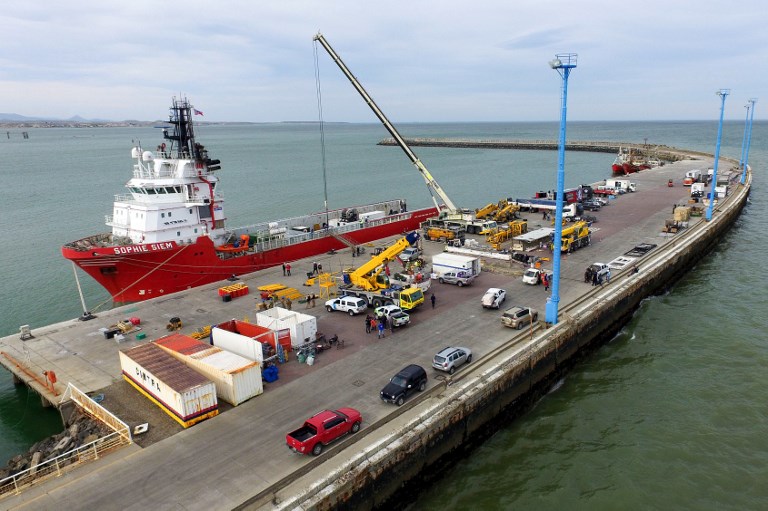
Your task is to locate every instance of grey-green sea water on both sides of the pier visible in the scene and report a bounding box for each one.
[0,121,768,509]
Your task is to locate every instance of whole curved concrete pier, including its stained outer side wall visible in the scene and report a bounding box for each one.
[0,147,751,510]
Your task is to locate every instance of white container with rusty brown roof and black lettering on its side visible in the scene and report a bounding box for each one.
[120,343,219,428]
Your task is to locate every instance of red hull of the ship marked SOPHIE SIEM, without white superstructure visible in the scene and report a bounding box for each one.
[62,208,437,303]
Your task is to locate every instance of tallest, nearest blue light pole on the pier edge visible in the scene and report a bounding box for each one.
[546,53,578,325]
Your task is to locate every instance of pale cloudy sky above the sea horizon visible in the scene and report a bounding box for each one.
[0,0,768,123]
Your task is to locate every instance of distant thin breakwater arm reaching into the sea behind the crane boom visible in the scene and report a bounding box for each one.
[377,138,688,161]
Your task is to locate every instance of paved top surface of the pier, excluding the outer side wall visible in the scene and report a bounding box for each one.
[0,156,744,509]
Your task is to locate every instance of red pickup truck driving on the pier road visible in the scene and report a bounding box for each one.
[285,408,363,456]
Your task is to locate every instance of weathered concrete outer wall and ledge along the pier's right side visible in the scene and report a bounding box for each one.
[246,161,752,510]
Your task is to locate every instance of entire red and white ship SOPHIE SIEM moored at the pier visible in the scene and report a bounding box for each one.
[61,98,438,303]
